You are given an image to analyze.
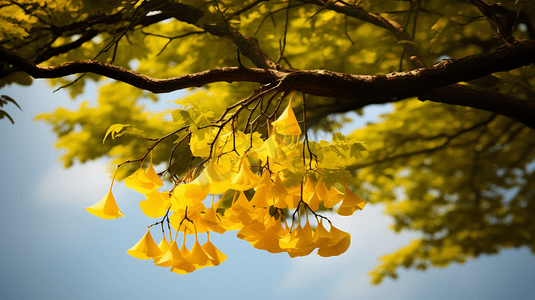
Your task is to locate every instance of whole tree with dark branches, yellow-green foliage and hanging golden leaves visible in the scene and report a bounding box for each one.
[0,0,535,283]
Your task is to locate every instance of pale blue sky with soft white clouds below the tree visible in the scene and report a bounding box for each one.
[0,81,535,300]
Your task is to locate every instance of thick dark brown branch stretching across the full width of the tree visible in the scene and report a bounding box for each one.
[0,40,535,128]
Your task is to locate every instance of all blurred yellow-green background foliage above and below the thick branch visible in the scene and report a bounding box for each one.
[0,0,535,283]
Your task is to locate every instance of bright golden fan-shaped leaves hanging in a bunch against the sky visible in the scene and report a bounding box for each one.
[87,103,366,274]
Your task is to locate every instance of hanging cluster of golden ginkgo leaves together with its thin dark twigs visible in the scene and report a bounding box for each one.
[87,94,366,274]
